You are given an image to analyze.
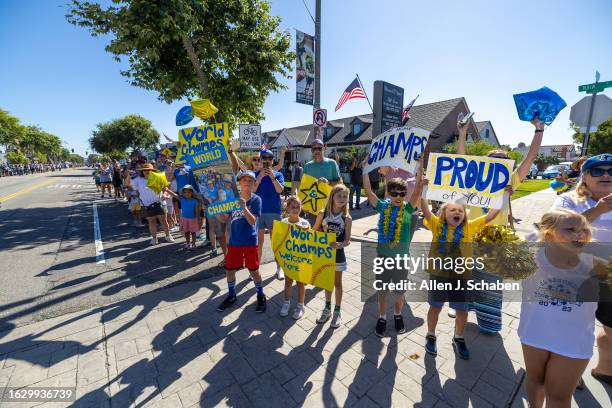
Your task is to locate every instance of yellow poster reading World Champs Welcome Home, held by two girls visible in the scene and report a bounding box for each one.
[272,221,336,291]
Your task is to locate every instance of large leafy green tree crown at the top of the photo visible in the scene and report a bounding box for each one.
[66,0,294,123]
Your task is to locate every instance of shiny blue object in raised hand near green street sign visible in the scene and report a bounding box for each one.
[514,86,567,125]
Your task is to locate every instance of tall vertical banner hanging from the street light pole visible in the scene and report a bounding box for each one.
[295,30,315,105]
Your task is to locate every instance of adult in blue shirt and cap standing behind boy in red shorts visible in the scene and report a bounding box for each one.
[255,149,285,280]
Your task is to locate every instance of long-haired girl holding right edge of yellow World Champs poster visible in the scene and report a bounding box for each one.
[313,184,352,329]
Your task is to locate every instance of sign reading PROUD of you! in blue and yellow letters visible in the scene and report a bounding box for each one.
[425,153,514,209]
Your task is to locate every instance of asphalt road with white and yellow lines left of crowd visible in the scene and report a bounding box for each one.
[0,169,273,331]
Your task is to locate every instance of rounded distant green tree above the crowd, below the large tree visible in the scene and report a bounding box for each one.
[89,115,159,157]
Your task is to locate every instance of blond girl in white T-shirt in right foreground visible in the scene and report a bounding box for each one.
[518,209,603,408]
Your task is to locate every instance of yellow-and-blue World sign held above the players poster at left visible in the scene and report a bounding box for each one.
[175,122,229,169]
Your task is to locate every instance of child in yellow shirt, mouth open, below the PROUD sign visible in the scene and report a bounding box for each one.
[421,179,499,360]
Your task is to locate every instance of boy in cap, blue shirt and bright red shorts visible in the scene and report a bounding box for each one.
[217,170,266,313]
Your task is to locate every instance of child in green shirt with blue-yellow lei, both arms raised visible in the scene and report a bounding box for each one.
[363,158,423,337]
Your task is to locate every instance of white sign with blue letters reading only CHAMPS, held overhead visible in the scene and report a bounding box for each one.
[363,126,429,174]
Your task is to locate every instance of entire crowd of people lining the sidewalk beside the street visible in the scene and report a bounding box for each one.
[94,119,612,407]
